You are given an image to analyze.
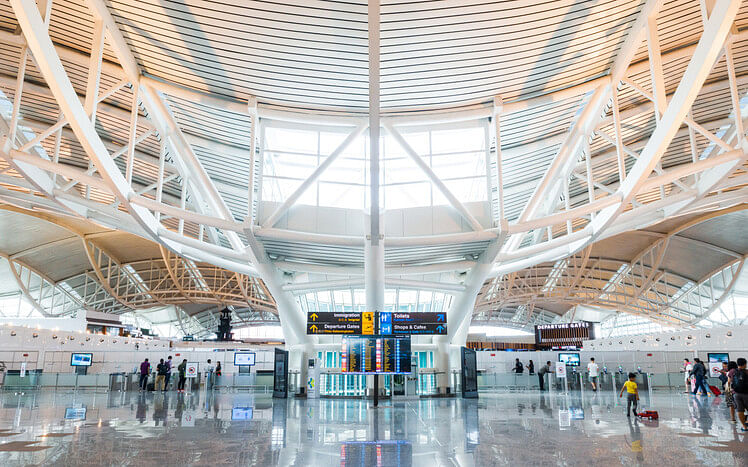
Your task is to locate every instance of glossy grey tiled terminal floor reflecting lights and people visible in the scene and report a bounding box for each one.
[0,391,748,467]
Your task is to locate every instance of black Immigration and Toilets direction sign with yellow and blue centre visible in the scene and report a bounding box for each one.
[306,311,447,336]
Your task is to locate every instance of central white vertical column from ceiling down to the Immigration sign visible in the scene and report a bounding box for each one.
[364,0,384,311]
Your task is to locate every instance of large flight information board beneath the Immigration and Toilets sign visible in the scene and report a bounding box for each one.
[340,337,410,375]
